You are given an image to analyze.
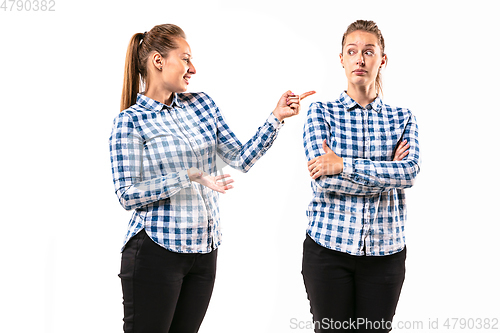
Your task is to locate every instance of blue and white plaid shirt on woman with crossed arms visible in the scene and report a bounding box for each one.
[303,92,420,256]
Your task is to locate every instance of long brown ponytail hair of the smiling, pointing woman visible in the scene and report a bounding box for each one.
[120,24,186,111]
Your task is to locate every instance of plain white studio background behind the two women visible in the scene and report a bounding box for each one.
[0,0,500,333]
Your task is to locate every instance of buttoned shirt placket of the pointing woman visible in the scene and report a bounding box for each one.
[166,105,215,249]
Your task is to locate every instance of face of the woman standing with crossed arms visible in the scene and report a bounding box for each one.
[340,30,387,91]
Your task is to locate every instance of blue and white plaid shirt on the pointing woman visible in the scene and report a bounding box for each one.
[109,93,282,253]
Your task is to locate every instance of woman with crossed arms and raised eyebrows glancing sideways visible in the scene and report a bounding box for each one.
[302,20,420,332]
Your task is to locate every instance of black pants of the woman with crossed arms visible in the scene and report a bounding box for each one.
[302,235,406,333]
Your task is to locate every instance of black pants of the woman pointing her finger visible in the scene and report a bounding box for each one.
[119,230,217,333]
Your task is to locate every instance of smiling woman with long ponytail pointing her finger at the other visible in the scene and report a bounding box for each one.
[110,24,314,333]
